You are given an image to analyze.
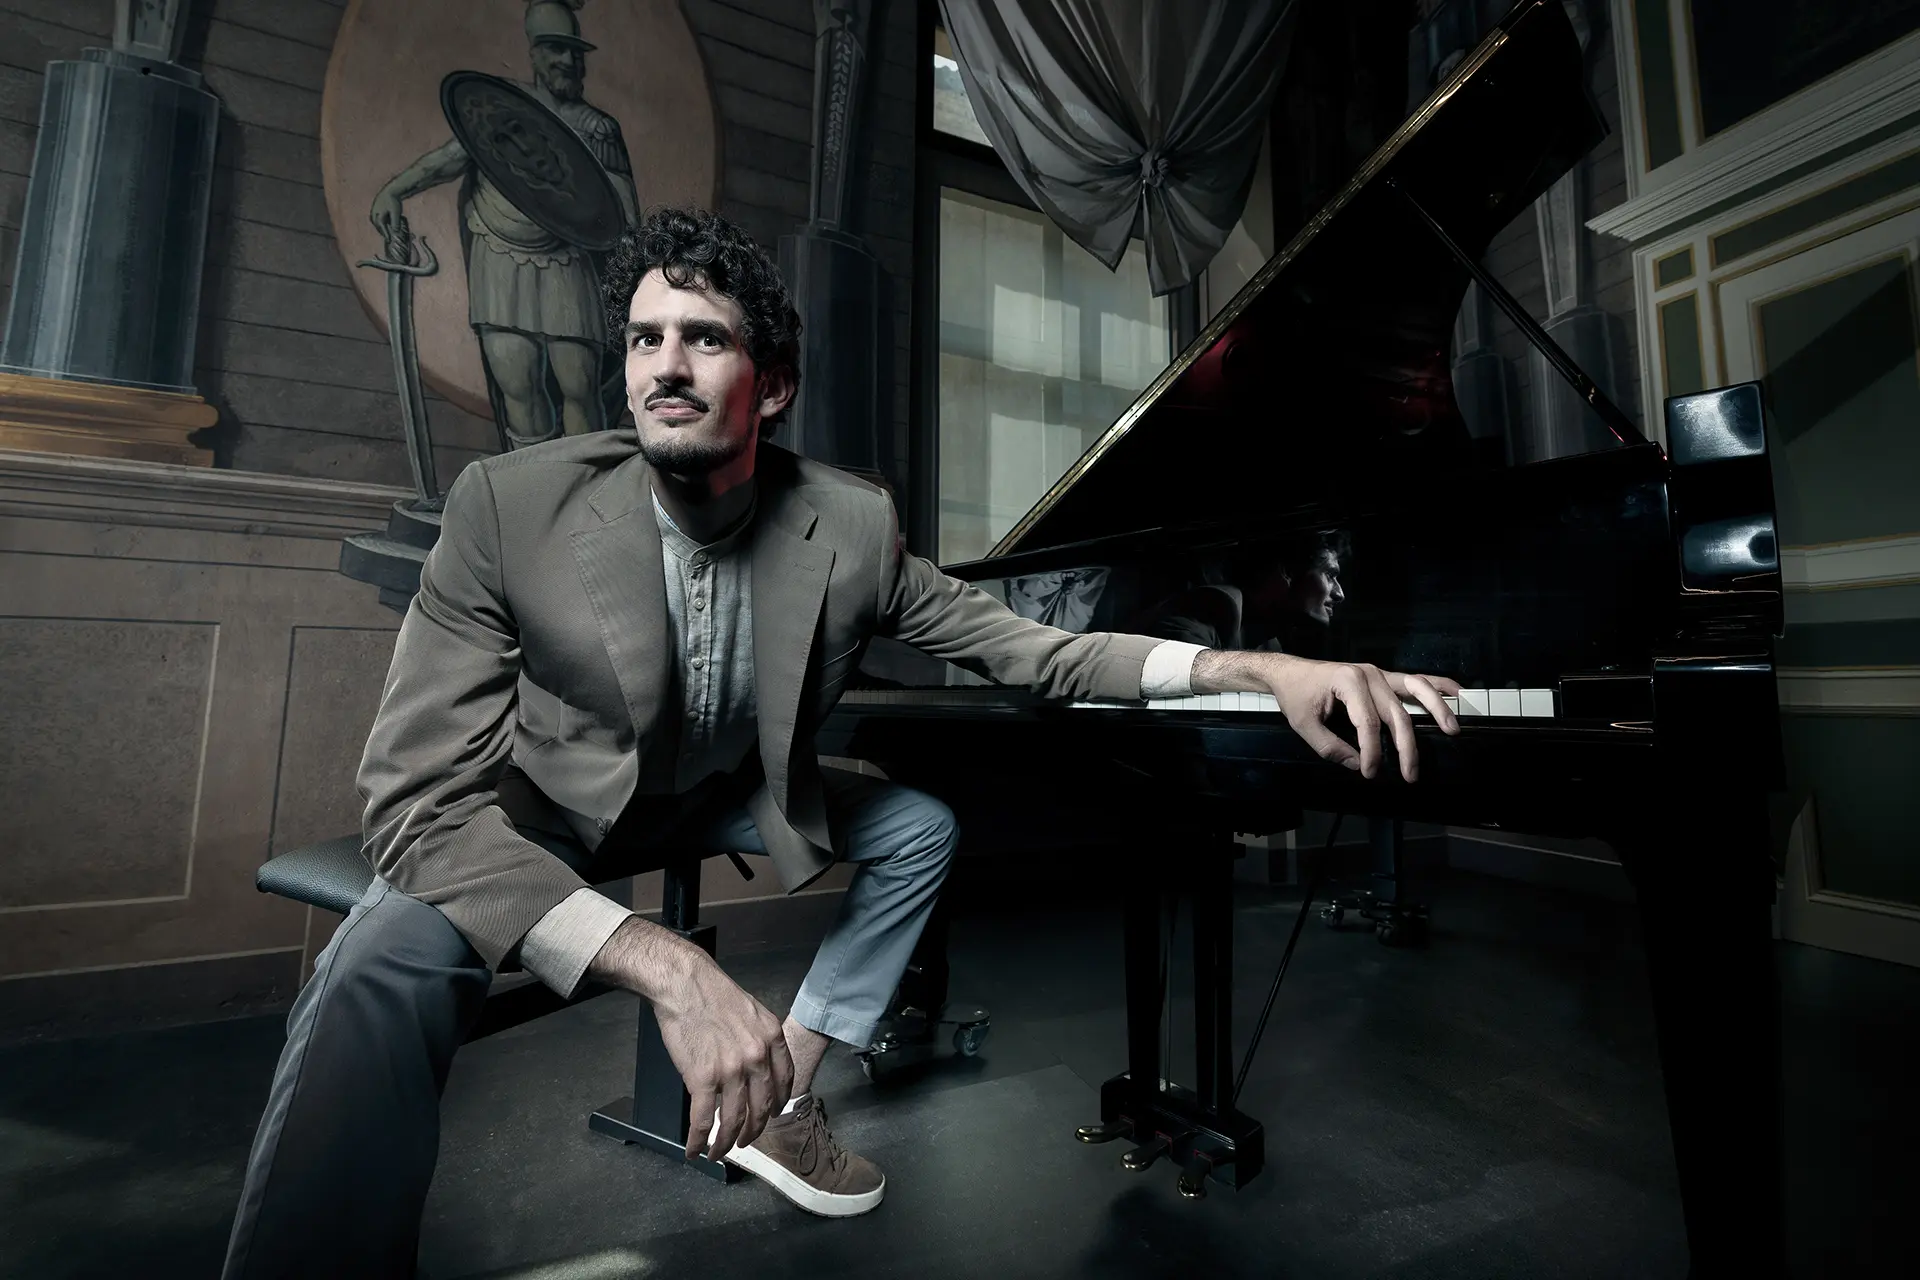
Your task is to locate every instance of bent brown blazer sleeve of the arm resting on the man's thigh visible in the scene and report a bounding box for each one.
[359,462,586,971]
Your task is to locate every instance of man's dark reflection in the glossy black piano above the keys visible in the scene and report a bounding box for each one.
[1133,530,1350,658]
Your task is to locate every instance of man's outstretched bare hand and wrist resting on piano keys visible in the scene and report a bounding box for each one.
[1192,649,1459,783]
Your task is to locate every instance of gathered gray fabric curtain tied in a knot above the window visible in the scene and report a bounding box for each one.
[941,0,1298,294]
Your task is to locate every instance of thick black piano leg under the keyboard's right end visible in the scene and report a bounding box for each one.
[1617,796,1786,1280]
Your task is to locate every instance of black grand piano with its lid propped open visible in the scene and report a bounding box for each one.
[820,0,1782,1276]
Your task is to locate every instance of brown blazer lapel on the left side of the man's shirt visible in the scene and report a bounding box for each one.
[572,453,670,771]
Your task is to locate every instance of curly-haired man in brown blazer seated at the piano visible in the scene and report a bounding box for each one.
[227,209,1455,1276]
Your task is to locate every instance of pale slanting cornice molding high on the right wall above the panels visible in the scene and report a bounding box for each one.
[1588,33,1920,244]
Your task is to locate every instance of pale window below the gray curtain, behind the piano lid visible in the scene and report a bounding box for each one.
[908,10,1175,564]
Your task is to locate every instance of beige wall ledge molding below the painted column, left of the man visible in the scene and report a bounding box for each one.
[0,449,413,541]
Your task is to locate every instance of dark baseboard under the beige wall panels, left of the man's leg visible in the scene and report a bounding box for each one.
[0,948,300,1044]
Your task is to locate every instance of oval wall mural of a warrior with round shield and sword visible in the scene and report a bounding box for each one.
[321,0,720,458]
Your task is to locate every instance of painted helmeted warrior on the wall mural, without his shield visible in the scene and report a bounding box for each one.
[371,0,639,447]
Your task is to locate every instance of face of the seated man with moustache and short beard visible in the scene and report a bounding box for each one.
[624,269,793,476]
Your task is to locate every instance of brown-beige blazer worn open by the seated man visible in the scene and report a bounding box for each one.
[359,430,1160,969]
